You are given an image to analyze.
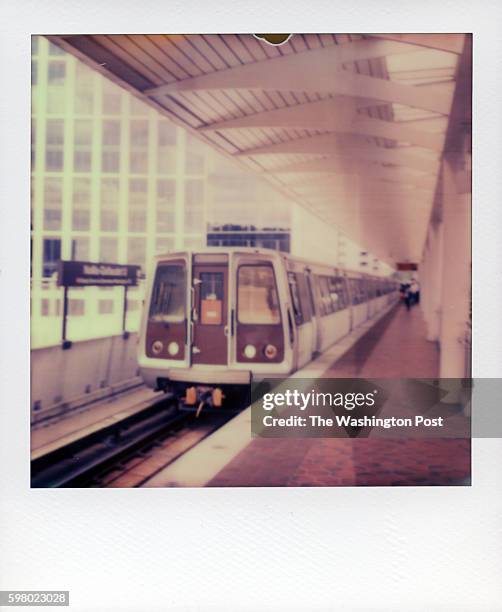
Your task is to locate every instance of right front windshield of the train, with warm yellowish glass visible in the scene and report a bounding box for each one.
[237,265,281,325]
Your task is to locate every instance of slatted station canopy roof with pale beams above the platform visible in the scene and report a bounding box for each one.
[49,34,471,262]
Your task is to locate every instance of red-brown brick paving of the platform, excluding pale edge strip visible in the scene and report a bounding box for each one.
[207,306,470,487]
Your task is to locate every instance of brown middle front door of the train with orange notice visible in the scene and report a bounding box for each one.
[192,255,228,365]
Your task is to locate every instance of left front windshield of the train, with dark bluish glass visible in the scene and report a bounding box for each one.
[149,264,186,322]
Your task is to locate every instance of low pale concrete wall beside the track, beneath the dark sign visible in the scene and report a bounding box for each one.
[31,334,141,422]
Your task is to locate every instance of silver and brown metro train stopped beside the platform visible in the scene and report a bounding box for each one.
[138,247,399,410]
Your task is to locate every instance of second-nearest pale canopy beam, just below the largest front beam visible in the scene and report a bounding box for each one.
[199,97,444,152]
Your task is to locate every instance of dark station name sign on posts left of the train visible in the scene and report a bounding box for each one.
[58,261,141,287]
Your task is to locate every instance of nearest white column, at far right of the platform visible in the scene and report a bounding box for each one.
[440,159,471,378]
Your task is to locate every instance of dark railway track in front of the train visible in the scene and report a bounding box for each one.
[31,398,230,488]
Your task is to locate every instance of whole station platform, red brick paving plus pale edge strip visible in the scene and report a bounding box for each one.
[144,304,470,487]
